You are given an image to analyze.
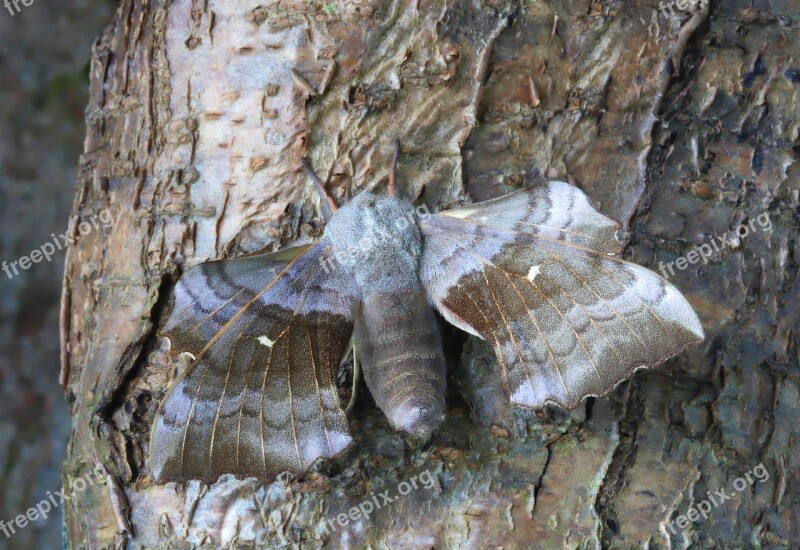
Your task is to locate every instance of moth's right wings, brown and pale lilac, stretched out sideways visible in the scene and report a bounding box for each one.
[420,182,704,408]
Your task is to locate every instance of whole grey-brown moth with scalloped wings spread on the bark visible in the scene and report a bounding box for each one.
[149,155,704,483]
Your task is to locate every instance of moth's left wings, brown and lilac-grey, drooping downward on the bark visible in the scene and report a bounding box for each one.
[150,244,359,482]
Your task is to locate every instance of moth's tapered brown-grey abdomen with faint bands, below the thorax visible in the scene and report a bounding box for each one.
[356,289,445,436]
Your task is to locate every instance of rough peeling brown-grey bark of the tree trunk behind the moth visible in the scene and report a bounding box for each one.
[62,0,800,548]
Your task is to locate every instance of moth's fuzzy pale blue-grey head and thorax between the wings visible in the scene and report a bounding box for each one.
[325,192,421,271]
